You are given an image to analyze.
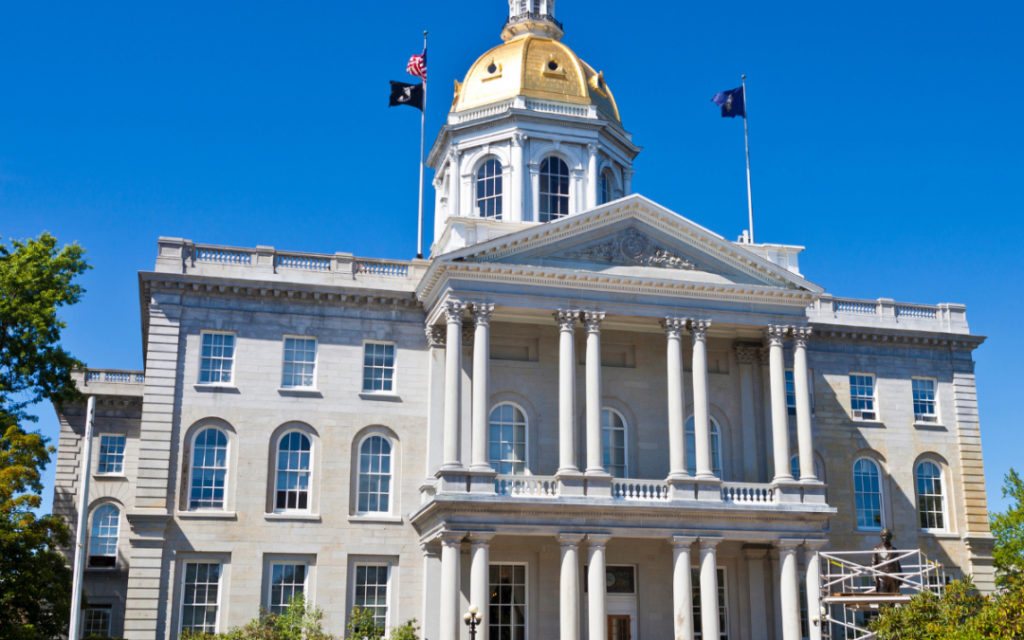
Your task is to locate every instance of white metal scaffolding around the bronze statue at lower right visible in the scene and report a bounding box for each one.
[820,549,945,640]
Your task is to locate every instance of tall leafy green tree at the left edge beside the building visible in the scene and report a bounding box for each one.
[0,233,89,640]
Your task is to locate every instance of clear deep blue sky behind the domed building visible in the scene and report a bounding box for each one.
[0,0,1024,514]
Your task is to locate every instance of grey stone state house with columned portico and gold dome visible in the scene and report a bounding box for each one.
[54,0,992,640]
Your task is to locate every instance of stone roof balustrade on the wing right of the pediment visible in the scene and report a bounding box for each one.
[807,294,970,334]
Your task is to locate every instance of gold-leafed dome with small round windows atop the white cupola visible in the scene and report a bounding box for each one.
[452,33,622,123]
